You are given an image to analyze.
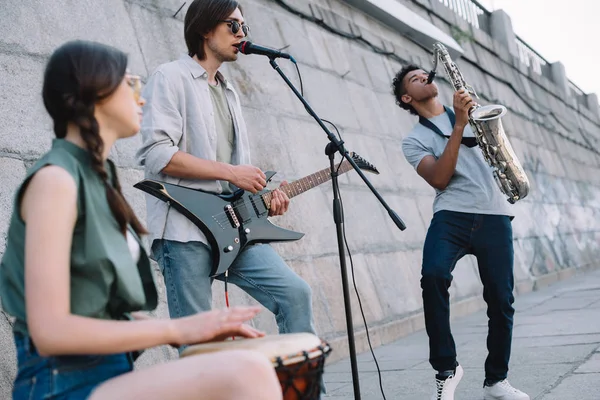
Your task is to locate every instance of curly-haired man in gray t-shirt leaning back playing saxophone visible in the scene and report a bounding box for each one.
[392,65,529,400]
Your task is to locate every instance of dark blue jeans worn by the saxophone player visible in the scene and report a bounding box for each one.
[421,211,515,382]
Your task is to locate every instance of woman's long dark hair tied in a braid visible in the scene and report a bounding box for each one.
[42,41,147,238]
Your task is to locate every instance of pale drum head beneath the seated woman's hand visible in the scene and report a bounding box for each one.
[181,333,323,365]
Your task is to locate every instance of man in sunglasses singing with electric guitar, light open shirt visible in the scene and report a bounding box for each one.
[137,0,315,360]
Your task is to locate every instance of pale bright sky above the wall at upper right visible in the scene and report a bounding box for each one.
[478,0,600,97]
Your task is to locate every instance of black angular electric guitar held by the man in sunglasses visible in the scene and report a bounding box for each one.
[133,153,379,277]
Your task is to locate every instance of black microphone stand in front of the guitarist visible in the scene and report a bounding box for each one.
[269,56,406,400]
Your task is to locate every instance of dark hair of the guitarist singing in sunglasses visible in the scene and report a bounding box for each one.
[183,0,242,60]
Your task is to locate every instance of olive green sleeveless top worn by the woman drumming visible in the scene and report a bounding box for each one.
[0,139,158,334]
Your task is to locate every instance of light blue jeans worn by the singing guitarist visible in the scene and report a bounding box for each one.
[152,239,316,334]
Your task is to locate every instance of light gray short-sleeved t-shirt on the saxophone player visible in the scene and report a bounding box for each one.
[402,108,514,217]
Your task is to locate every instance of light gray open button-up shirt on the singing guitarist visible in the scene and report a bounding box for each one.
[136,55,250,247]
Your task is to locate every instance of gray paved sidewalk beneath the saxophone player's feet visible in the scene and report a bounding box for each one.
[323,271,600,400]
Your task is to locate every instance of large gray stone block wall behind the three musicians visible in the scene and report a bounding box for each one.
[0,0,600,398]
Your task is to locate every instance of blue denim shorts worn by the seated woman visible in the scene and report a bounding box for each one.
[13,333,133,400]
